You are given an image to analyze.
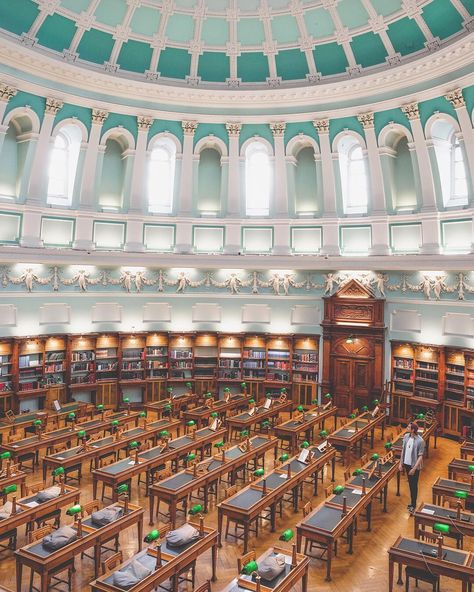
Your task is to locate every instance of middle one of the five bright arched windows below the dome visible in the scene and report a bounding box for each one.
[245,140,272,216]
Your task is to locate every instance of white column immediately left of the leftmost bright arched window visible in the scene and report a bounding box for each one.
[26,97,64,204]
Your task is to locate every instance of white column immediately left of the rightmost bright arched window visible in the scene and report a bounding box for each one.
[402,103,436,212]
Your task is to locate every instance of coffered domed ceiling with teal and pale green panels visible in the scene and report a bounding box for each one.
[0,0,474,88]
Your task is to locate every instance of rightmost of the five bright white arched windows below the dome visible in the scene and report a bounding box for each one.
[431,118,468,207]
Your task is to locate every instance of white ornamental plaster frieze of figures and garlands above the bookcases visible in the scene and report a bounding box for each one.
[0,264,474,300]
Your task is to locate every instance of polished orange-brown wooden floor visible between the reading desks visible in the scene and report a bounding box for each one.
[0,432,466,592]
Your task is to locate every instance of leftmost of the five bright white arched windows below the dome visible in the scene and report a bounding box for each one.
[47,124,82,205]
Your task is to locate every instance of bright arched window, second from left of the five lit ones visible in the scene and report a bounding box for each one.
[147,138,176,214]
